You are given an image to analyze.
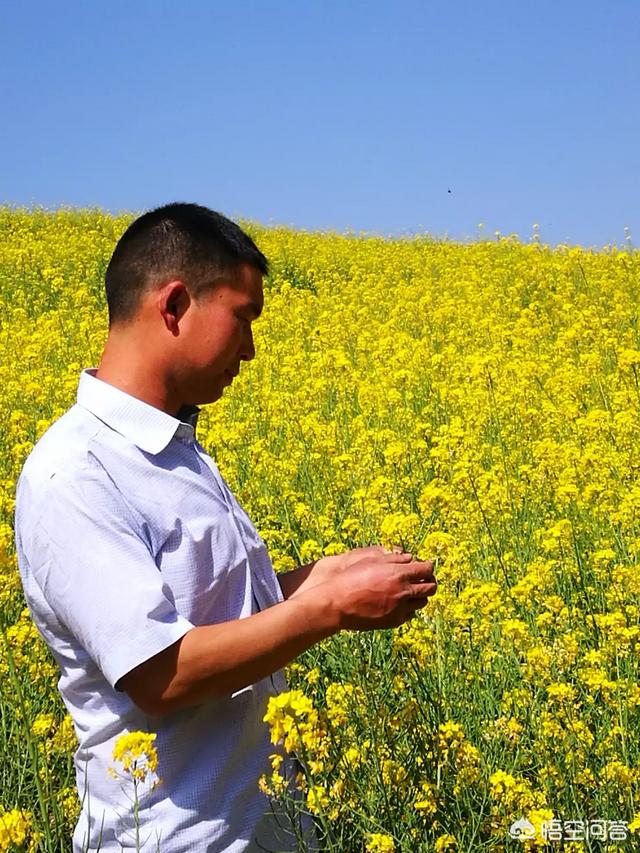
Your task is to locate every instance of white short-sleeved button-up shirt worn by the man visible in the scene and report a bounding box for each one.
[16,370,296,853]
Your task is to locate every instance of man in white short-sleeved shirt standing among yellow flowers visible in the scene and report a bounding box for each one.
[16,204,436,853]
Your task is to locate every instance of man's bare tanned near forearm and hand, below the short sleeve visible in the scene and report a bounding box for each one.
[118,554,436,715]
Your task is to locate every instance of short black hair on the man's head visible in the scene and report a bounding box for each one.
[105,202,269,326]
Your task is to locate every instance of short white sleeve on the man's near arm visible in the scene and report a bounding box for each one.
[22,456,194,687]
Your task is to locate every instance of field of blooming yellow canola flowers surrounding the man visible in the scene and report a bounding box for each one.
[0,209,640,853]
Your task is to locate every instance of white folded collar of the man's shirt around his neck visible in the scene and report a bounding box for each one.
[78,367,200,456]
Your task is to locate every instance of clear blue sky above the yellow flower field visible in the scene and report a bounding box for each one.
[0,0,640,246]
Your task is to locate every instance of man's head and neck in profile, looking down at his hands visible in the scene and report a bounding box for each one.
[97,204,267,413]
